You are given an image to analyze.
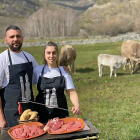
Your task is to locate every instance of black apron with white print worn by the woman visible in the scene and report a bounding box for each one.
[36,65,69,123]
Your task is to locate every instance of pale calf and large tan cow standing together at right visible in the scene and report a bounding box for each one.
[98,40,140,77]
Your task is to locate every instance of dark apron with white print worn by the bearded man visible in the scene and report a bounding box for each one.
[0,49,34,127]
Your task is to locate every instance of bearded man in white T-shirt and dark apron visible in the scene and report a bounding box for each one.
[0,25,38,128]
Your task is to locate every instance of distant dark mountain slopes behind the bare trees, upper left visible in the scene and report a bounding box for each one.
[0,0,96,38]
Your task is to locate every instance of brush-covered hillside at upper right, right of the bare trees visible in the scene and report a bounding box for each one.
[81,0,140,36]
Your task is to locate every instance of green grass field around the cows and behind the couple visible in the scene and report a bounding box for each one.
[0,42,140,140]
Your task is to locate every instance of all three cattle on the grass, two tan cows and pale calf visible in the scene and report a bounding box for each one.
[59,40,140,77]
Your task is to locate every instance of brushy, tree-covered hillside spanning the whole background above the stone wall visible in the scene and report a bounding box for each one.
[0,0,140,38]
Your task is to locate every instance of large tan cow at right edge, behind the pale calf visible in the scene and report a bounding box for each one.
[121,40,140,74]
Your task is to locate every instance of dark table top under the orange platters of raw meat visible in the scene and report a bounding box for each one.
[1,118,100,140]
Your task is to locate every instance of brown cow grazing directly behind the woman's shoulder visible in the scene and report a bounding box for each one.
[59,45,76,73]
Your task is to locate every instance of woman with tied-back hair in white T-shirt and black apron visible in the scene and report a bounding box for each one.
[33,41,81,123]
